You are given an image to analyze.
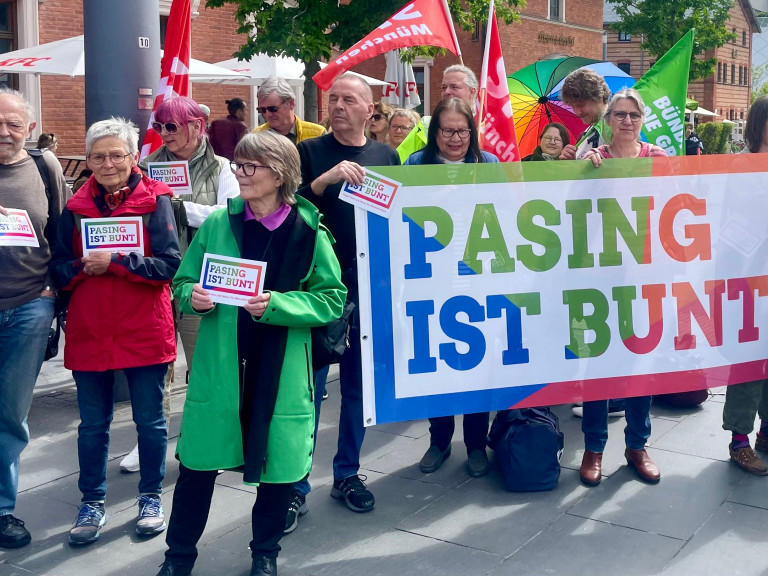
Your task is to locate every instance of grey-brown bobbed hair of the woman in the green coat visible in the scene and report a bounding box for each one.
[235,130,301,204]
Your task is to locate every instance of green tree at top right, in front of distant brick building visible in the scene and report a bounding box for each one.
[607,0,735,82]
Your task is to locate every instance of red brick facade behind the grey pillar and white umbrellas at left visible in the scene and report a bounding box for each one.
[0,0,250,155]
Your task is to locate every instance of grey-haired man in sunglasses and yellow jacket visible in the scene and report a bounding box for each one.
[254,76,325,144]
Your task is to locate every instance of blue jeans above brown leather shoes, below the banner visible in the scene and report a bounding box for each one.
[581,396,651,453]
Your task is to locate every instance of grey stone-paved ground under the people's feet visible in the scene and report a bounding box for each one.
[0,358,768,576]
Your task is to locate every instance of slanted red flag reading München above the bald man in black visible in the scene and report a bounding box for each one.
[312,0,461,90]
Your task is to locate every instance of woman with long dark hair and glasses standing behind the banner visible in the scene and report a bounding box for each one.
[404,98,499,478]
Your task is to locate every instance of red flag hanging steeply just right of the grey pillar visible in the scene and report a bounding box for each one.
[141,0,192,158]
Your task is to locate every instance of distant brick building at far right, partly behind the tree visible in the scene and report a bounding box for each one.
[604,0,760,122]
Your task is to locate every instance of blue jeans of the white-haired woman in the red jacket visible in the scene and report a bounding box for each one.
[72,364,168,502]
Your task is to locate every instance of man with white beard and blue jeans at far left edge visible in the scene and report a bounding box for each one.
[0,88,67,548]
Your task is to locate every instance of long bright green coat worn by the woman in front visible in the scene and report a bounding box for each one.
[173,197,346,483]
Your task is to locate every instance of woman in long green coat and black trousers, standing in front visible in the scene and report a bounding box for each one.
[158,132,346,576]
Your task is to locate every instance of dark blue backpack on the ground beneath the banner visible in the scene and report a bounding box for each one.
[488,408,563,492]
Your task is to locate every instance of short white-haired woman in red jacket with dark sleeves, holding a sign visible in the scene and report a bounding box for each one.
[51,118,181,545]
